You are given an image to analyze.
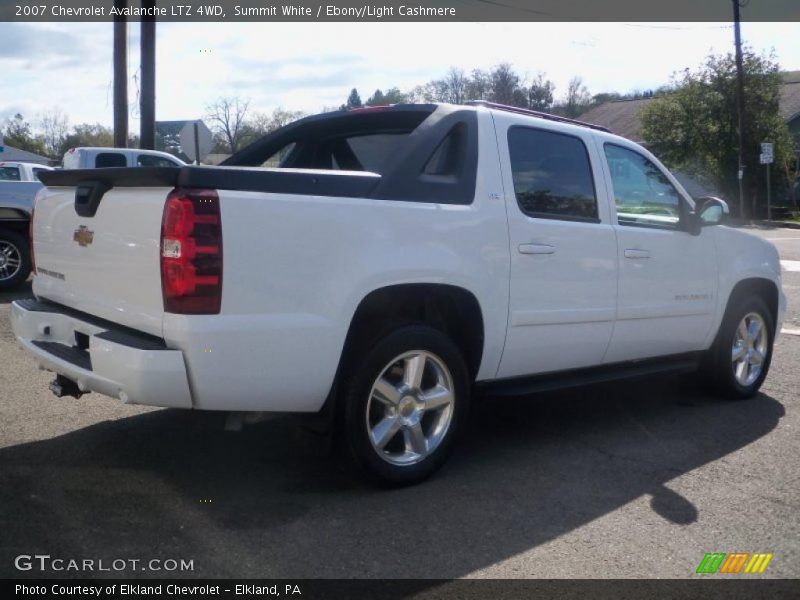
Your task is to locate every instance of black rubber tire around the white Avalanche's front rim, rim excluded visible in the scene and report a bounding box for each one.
[707,296,775,400]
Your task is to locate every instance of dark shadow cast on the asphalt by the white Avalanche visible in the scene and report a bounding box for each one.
[0,378,784,578]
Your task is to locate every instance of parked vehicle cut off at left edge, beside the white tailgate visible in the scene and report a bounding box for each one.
[0,161,52,291]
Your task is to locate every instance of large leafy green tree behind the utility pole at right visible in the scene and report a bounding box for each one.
[641,48,793,213]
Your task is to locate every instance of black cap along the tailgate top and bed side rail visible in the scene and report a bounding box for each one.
[40,166,381,198]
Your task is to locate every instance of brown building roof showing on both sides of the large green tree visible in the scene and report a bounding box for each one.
[580,71,800,142]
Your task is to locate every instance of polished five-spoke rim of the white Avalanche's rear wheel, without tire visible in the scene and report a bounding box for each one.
[366,350,455,466]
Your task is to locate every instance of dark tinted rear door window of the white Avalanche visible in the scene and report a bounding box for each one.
[508,127,598,222]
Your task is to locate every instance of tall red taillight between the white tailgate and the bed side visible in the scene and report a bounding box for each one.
[161,188,222,315]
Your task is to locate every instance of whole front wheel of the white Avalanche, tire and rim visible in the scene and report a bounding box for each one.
[713,297,775,399]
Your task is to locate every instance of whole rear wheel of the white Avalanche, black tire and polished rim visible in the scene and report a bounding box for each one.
[340,325,469,485]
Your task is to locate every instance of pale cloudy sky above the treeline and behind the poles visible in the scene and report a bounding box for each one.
[0,22,800,132]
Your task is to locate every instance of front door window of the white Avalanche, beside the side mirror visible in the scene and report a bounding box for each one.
[603,144,681,229]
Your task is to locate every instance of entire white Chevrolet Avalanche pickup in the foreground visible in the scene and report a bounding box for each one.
[12,103,786,484]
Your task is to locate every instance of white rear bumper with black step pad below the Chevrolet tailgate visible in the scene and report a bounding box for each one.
[11,299,192,408]
